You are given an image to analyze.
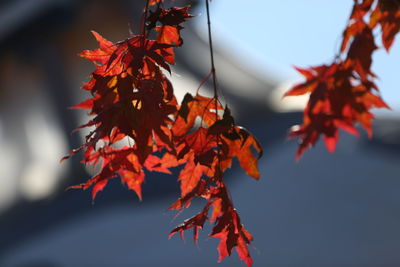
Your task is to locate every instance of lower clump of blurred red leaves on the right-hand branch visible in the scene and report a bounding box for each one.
[285,62,388,159]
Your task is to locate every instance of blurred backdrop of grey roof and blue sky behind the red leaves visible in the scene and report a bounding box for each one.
[0,0,400,267]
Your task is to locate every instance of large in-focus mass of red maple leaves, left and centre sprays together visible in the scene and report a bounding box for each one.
[63,0,262,266]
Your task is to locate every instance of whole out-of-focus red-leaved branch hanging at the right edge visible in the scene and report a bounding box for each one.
[285,0,400,159]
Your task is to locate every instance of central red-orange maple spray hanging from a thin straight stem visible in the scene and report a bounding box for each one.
[170,0,262,266]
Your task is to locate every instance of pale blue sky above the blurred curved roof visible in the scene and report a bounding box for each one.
[195,0,400,110]
